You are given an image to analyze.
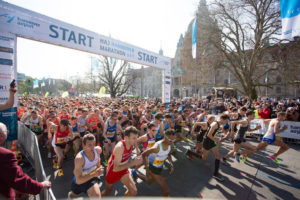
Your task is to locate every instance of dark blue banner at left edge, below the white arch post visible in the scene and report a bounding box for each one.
[0,107,18,141]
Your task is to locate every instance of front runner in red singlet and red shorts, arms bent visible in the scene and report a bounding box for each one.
[102,126,143,196]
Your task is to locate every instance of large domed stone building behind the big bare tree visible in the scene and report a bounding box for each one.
[171,0,300,98]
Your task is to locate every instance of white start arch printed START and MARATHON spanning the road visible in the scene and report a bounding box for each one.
[0,1,171,103]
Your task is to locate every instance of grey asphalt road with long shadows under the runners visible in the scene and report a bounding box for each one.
[42,139,300,200]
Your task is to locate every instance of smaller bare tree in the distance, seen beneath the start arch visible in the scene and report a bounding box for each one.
[98,56,136,98]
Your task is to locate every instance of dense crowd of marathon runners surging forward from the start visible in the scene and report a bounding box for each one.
[18,96,300,198]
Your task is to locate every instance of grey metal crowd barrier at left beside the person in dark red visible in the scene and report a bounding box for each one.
[17,122,56,200]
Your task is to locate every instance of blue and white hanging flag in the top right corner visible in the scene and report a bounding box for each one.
[280,0,300,40]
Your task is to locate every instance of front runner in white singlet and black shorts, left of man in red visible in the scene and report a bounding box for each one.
[68,133,104,199]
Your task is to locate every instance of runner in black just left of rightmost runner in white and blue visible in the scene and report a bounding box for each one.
[220,110,261,166]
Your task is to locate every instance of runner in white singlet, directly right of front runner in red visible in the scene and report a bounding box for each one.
[137,129,176,196]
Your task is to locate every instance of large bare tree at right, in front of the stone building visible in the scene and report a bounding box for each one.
[207,0,290,99]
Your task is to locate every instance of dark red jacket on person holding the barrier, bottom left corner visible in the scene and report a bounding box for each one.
[0,147,43,199]
